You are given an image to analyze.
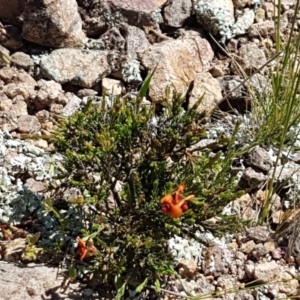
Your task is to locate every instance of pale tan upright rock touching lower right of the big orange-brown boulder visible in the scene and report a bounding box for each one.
[188,72,223,115]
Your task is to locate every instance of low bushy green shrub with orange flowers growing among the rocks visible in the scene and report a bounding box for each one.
[48,90,244,298]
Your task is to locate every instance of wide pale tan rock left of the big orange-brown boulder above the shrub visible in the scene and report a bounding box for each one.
[40,49,110,88]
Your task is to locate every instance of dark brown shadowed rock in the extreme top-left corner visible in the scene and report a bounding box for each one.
[0,0,26,25]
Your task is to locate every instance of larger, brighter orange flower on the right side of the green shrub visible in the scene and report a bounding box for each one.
[160,182,195,218]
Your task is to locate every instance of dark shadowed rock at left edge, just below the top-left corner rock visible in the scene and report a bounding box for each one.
[0,23,23,51]
